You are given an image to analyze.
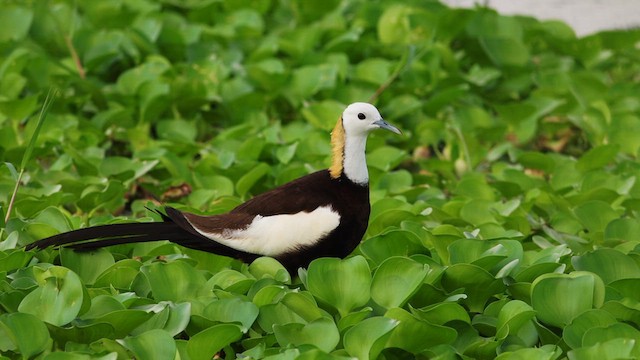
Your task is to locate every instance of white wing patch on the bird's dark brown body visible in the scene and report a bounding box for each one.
[190,206,340,256]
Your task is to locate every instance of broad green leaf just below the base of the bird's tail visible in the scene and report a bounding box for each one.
[140,261,206,302]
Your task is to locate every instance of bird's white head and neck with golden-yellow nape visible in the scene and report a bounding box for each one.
[329,102,400,185]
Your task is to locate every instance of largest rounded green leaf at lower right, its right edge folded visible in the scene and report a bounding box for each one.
[531,271,605,327]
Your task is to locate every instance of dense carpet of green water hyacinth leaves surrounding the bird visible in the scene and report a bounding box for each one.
[0,0,640,360]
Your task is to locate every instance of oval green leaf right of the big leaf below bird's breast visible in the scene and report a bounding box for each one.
[371,257,429,309]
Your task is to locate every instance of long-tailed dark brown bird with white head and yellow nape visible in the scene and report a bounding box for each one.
[26,102,401,273]
